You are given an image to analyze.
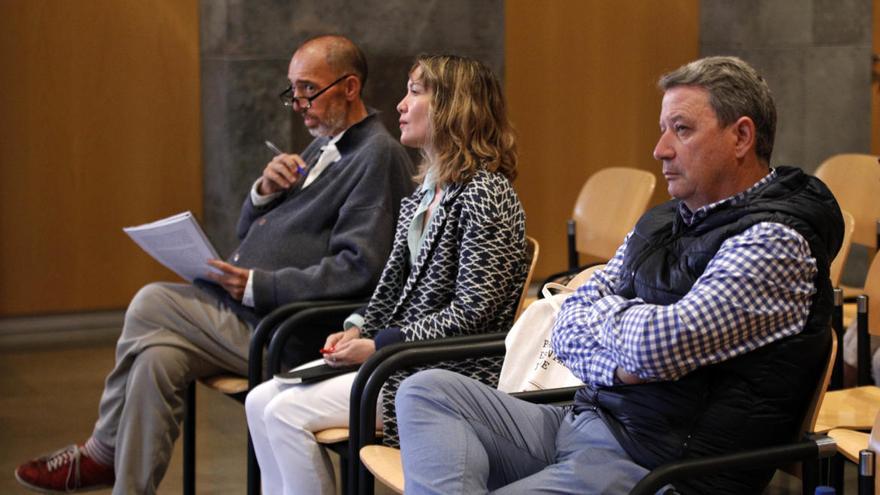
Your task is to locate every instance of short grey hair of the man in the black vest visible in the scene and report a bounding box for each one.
[657,57,776,165]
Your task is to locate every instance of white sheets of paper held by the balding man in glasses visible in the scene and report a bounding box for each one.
[122,211,219,282]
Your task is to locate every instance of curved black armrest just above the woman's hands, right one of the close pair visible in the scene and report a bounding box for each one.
[267,301,369,374]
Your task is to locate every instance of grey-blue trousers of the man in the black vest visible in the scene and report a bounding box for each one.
[395,370,648,495]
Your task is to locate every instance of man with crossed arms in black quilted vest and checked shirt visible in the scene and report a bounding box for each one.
[397,57,843,494]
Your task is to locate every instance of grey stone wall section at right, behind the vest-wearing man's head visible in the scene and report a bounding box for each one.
[700,0,872,172]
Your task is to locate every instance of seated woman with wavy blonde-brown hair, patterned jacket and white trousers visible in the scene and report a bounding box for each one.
[246,55,527,494]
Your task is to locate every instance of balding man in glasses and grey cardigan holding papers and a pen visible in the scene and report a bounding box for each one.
[15,36,412,494]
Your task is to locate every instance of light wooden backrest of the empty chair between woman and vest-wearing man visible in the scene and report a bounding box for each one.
[572,167,657,261]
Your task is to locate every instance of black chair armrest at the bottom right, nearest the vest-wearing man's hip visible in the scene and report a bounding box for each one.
[629,435,837,495]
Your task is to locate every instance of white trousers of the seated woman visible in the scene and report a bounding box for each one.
[245,360,382,495]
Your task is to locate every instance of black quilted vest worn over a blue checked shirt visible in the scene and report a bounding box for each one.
[575,167,843,494]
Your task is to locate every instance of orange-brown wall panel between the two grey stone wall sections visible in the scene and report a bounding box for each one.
[505,0,699,276]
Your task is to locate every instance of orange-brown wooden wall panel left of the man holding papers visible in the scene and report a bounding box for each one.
[0,0,202,316]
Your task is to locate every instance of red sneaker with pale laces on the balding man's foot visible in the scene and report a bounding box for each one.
[15,445,116,493]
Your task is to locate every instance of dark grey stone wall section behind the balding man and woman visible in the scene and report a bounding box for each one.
[200,0,504,255]
